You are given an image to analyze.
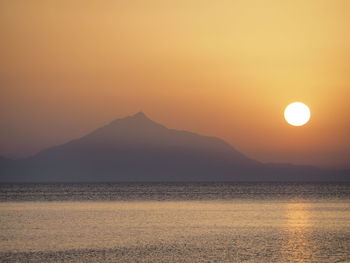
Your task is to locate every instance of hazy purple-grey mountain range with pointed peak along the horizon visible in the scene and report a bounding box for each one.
[0,112,349,182]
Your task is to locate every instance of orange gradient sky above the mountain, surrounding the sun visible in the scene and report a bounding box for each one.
[0,0,350,168]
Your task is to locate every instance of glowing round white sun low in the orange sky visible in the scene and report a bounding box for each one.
[284,102,311,126]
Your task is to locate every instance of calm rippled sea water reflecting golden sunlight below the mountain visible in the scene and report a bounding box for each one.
[0,183,350,263]
